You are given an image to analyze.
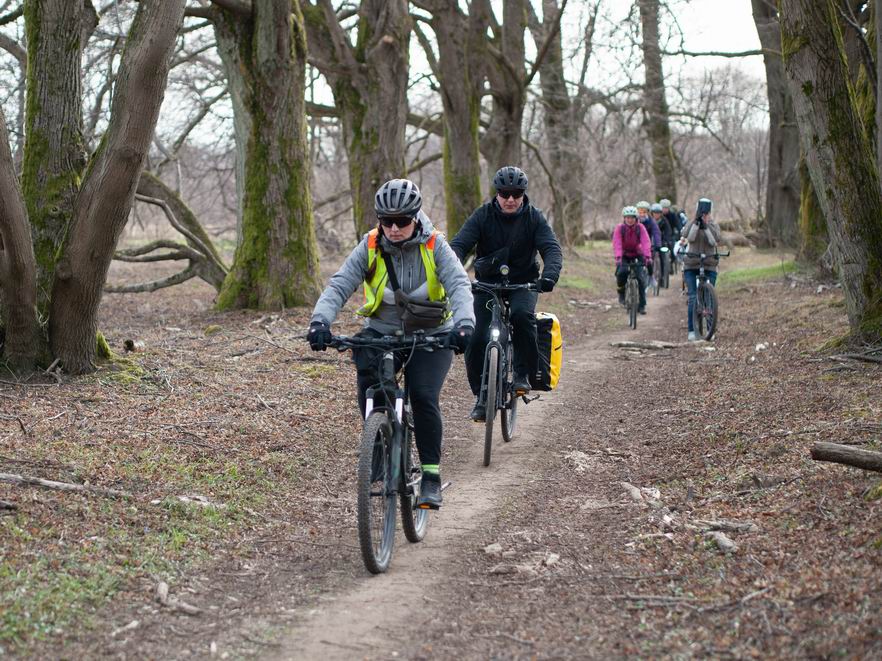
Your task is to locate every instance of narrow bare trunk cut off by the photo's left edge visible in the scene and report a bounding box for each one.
[0,108,40,372]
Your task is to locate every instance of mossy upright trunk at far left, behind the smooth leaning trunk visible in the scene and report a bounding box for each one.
[21,0,86,319]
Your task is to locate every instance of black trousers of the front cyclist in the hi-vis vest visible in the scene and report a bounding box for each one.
[352,328,453,464]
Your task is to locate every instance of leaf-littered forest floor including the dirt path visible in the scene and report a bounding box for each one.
[0,244,882,659]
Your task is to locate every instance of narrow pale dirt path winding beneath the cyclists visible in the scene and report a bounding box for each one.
[273,290,682,659]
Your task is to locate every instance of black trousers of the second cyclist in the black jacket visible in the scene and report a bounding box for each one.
[465,289,539,395]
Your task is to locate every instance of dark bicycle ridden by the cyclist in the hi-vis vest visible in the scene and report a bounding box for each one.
[330,331,448,574]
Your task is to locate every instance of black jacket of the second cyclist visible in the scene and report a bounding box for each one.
[450,195,563,284]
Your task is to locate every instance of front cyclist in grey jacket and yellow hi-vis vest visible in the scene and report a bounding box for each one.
[307,179,475,508]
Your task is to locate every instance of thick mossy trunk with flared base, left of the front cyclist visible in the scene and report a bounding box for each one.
[217,0,320,310]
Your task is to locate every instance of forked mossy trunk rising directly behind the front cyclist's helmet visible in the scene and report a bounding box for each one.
[301,0,411,238]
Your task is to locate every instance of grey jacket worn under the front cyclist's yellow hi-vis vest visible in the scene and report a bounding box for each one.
[310,211,475,335]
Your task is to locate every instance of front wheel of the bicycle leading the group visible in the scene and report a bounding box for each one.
[357,411,395,574]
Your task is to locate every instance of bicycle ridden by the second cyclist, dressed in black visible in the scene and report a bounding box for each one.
[472,265,538,466]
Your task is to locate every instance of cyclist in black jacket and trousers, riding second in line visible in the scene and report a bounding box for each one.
[450,165,563,422]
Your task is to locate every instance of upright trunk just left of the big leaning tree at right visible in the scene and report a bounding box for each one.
[752,0,800,248]
